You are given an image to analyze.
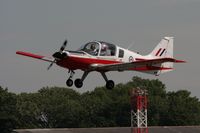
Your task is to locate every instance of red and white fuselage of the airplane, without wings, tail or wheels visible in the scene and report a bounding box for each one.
[57,41,150,71]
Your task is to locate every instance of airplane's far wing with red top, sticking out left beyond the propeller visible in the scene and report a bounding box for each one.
[16,51,54,62]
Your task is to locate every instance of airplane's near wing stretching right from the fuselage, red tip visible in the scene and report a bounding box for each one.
[92,58,185,71]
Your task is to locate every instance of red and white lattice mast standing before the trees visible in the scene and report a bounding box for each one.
[131,88,148,133]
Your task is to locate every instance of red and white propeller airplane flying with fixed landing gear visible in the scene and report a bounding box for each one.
[16,37,185,89]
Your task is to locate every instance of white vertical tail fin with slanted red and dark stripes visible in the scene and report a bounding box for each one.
[150,37,174,75]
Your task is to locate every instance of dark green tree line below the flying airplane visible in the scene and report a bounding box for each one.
[0,77,200,132]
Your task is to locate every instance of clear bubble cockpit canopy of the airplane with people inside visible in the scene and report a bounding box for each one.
[79,41,116,56]
